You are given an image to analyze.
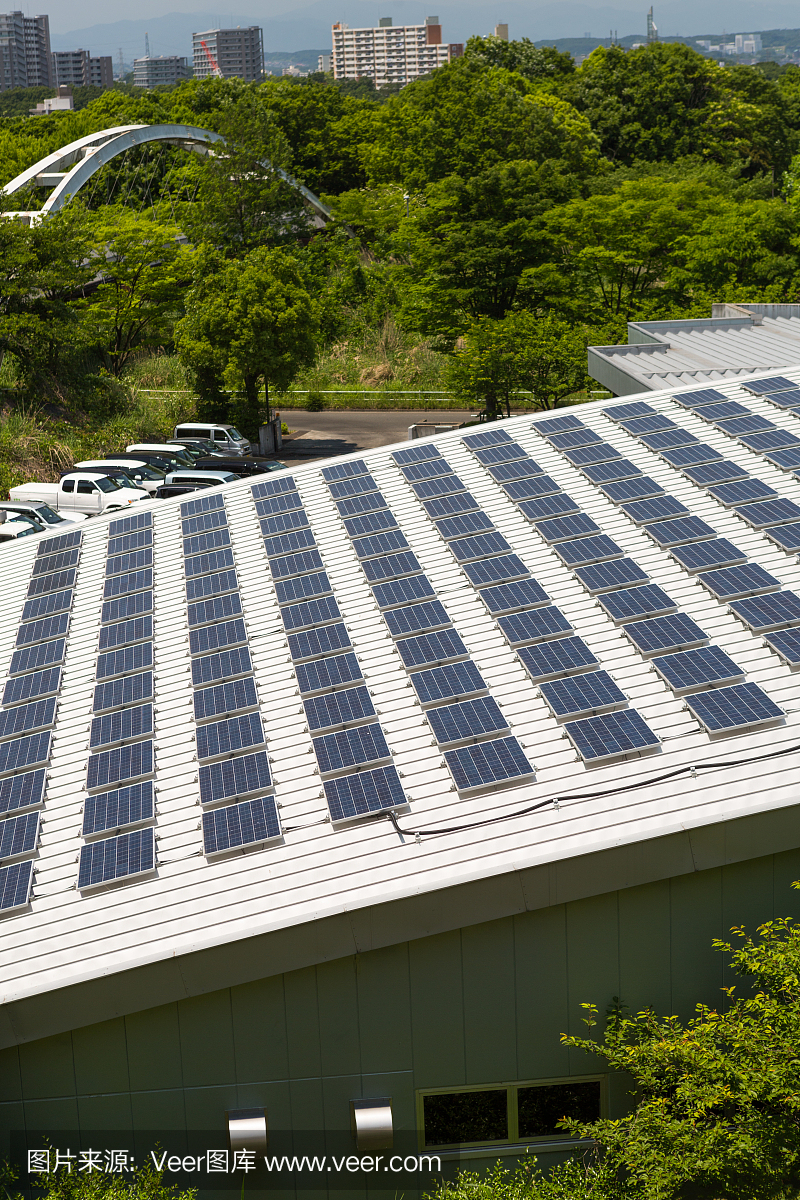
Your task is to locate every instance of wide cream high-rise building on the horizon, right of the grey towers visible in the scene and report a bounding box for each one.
[331,17,464,88]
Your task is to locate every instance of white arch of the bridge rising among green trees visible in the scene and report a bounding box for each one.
[1,125,332,226]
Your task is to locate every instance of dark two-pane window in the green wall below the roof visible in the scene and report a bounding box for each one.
[419,1076,604,1148]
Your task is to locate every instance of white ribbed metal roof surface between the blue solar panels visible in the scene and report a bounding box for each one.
[0,366,800,1004]
